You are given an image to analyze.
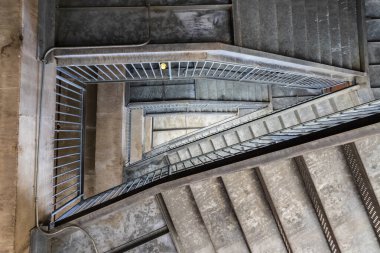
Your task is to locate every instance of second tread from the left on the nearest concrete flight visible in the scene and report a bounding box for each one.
[190,179,249,253]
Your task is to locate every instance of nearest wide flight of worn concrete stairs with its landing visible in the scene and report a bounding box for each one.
[52,135,380,253]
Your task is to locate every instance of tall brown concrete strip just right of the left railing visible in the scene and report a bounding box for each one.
[95,83,125,193]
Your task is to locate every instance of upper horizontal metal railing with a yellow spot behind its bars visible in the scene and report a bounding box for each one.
[58,61,348,89]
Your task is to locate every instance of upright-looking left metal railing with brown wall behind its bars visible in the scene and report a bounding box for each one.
[51,71,85,220]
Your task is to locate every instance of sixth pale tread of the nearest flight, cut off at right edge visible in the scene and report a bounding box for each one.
[355,135,380,201]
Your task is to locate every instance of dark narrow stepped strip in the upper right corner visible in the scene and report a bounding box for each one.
[365,0,380,98]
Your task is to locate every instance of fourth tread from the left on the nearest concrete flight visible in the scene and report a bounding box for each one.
[260,160,329,252]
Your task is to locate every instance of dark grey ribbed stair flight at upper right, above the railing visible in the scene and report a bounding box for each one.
[235,0,360,70]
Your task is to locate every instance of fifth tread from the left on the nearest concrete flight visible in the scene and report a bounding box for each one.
[304,147,378,252]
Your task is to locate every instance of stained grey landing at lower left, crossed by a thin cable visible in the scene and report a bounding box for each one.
[52,198,166,253]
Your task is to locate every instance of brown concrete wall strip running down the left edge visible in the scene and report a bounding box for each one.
[0,0,21,253]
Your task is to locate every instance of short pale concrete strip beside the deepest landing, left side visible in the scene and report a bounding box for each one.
[130,109,144,163]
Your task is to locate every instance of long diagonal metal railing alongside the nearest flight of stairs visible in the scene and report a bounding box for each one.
[52,100,380,224]
